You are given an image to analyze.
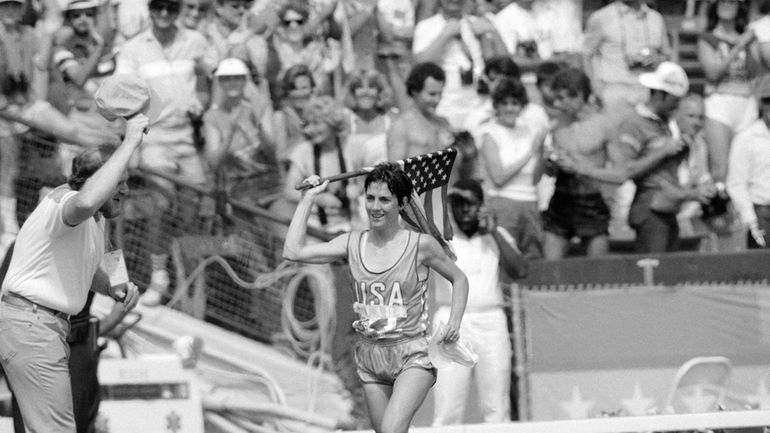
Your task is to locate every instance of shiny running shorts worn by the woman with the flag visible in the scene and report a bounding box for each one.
[354,336,436,385]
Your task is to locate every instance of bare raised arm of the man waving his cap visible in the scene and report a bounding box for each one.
[62,113,148,226]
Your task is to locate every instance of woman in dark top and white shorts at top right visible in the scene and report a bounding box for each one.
[698,0,758,182]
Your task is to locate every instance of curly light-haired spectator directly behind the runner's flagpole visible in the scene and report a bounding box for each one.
[284,96,354,233]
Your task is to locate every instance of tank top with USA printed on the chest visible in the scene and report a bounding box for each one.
[348,231,429,340]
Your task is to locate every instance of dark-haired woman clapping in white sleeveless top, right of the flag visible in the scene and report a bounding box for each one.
[480,78,548,259]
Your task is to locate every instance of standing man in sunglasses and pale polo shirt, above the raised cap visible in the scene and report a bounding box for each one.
[115,0,217,304]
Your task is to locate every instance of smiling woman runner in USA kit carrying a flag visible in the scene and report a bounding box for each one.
[283,163,468,433]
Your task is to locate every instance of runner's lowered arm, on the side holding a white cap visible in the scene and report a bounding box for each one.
[418,236,468,343]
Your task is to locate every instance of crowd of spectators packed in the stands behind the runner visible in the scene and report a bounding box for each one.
[0,0,770,291]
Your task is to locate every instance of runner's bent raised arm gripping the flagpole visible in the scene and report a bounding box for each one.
[283,175,349,263]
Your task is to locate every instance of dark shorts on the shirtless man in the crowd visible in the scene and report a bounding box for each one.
[543,189,610,239]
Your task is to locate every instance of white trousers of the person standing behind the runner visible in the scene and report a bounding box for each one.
[433,307,511,426]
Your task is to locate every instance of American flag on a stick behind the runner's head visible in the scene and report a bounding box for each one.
[398,148,457,244]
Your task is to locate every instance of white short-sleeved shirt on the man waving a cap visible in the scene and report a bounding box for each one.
[3,186,104,315]
